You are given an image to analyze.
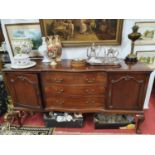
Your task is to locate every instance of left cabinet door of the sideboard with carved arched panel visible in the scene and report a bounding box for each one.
[5,73,42,109]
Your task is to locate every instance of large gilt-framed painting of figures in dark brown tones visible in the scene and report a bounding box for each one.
[40,19,123,46]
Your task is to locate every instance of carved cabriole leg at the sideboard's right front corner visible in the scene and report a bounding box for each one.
[136,114,145,134]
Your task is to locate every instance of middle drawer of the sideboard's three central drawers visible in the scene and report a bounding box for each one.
[44,84,105,97]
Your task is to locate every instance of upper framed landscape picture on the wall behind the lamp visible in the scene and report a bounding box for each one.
[135,22,155,45]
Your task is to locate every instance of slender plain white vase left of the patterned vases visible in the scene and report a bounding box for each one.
[38,37,51,62]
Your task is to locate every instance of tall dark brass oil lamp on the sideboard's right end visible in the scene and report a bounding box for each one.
[125,25,141,64]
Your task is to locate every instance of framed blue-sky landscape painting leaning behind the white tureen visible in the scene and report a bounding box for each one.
[5,23,42,58]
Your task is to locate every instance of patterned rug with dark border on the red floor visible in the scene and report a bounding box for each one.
[0,126,53,135]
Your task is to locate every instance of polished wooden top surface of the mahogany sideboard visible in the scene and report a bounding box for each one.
[3,60,153,72]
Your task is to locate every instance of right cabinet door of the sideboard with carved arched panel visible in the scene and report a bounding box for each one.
[106,73,149,110]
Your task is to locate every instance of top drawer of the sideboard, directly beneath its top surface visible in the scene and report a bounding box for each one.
[42,72,107,84]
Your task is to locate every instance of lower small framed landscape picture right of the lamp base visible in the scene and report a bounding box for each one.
[136,50,155,65]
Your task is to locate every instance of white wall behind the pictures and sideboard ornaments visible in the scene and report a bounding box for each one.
[1,19,155,60]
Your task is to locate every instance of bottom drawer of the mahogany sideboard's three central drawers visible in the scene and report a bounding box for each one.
[45,96,105,109]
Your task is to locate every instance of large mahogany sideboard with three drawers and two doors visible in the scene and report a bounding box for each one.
[3,60,152,133]
